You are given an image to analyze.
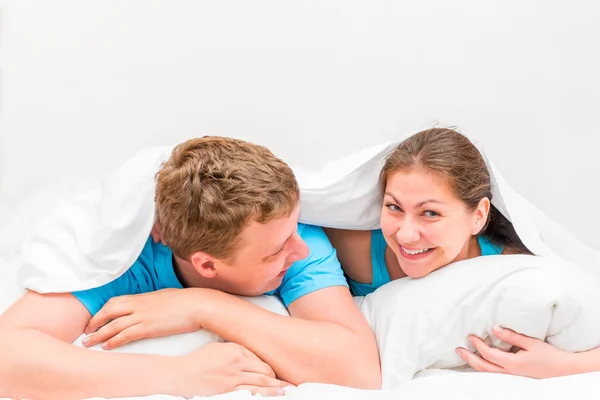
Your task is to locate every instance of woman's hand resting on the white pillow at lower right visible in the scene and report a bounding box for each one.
[456,327,576,379]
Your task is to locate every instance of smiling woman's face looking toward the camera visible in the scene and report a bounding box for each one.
[381,167,489,278]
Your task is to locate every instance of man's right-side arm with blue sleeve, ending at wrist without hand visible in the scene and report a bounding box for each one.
[198,225,381,389]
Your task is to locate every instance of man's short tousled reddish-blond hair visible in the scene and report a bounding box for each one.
[155,136,300,260]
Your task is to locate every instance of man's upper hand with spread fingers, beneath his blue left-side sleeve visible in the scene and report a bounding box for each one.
[83,289,201,350]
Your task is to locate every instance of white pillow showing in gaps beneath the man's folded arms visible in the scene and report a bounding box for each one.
[73,296,289,356]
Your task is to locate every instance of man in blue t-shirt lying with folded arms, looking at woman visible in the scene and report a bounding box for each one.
[0,137,381,399]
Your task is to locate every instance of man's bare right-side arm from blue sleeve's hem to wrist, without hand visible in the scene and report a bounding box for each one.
[198,286,381,389]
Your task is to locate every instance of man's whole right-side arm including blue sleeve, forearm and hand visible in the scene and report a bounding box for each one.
[87,226,381,388]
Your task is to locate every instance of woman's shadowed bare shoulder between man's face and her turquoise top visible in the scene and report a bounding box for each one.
[323,228,373,283]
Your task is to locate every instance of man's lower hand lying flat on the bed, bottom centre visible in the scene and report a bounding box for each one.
[169,343,290,398]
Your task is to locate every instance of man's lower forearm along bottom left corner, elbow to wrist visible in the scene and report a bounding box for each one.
[0,330,171,400]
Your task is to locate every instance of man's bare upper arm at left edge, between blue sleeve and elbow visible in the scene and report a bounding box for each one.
[0,291,91,343]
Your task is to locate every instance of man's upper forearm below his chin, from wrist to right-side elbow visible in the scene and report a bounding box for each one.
[198,292,380,389]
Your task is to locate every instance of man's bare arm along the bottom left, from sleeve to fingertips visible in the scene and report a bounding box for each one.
[0,292,282,400]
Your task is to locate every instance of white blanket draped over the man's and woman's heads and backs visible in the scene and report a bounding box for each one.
[19,131,600,293]
